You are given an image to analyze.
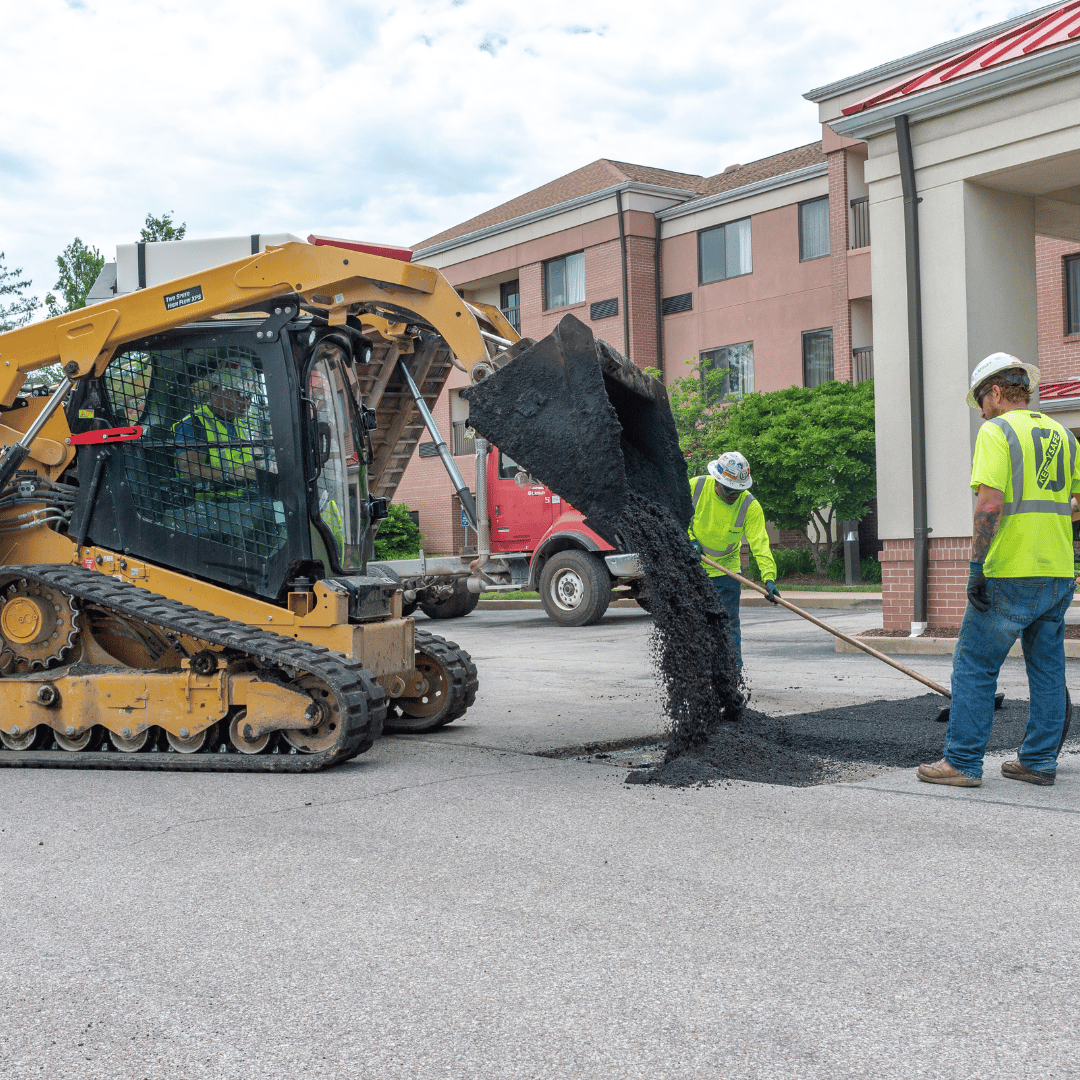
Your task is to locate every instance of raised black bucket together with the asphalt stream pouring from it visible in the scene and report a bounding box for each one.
[464,315,745,760]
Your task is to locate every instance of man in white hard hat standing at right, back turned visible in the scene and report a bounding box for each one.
[918,352,1080,787]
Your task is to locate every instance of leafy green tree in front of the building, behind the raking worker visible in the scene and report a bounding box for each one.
[670,368,877,572]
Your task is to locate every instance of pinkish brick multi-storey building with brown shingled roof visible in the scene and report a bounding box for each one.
[397,2,1080,627]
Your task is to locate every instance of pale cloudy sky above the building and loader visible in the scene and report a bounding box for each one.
[0,0,1041,308]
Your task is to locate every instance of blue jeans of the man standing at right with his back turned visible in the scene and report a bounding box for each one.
[945,578,1076,777]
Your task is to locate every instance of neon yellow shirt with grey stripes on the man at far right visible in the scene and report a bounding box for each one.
[971,408,1080,578]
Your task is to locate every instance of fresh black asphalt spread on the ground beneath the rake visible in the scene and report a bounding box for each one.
[626,693,1080,787]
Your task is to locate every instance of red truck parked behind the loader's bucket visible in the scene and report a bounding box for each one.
[378,429,648,626]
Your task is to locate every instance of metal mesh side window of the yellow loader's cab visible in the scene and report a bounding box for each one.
[103,346,285,557]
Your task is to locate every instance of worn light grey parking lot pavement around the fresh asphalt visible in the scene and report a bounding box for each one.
[0,609,1080,1080]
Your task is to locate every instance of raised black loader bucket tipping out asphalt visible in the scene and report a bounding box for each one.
[463,315,693,550]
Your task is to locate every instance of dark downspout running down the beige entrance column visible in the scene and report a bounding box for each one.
[896,113,930,637]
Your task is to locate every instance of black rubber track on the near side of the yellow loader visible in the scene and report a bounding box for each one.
[0,566,386,772]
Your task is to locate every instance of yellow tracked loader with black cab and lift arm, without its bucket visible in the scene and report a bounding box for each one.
[0,243,685,771]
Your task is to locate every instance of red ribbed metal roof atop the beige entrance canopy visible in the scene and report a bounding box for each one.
[843,0,1080,117]
